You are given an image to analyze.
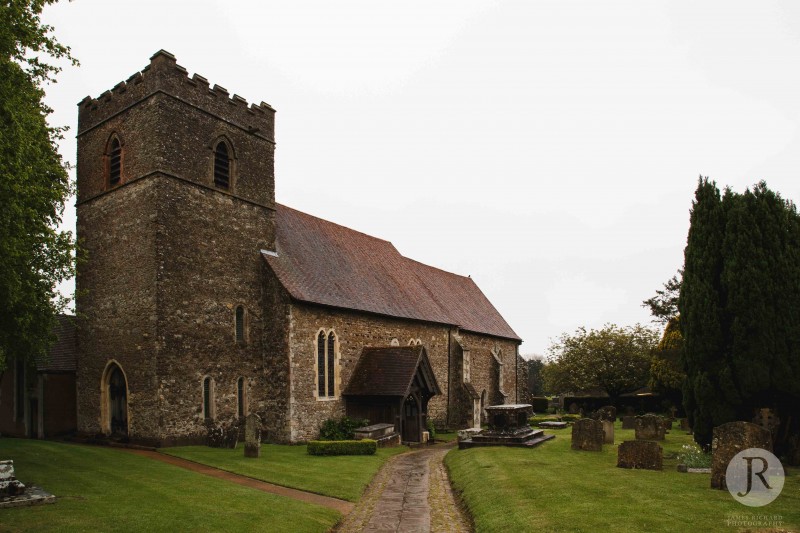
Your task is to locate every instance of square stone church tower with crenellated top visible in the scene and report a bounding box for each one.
[76,51,275,444]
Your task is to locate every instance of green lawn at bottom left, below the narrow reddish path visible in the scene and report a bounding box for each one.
[0,438,341,532]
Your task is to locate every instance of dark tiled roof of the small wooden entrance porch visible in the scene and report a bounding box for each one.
[342,346,442,397]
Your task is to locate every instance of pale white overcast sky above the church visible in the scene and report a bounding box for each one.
[43,0,800,354]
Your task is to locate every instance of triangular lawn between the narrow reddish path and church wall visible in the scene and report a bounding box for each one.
[161,438,408,502]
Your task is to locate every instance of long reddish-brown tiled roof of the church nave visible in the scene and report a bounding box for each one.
[264,204,520,341]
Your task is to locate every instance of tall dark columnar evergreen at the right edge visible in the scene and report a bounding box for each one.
[679,178,800,448]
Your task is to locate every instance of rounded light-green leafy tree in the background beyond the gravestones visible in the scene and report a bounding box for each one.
[544,324,658,399]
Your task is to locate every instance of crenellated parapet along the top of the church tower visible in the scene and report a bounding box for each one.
[78,50,275,142]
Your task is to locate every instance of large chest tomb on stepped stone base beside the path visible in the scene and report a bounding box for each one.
[458,403,555,449]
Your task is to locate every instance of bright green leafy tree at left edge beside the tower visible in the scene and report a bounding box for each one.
[0,0,76,371]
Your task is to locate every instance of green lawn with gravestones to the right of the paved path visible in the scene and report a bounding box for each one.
[445,422,800,533]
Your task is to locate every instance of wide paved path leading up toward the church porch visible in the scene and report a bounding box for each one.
[336,443,472,533]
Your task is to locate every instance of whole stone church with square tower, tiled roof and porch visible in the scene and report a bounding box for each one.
[76,50,526,446]
